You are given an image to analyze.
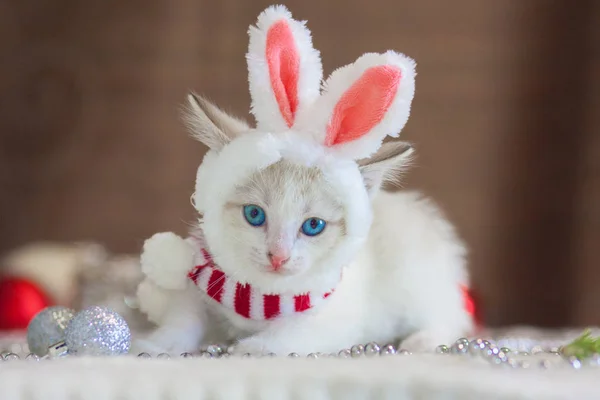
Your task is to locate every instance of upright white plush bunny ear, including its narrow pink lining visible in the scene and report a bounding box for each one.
[246,6,323,132]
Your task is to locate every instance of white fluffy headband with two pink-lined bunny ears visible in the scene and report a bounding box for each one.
[194,6,415,241]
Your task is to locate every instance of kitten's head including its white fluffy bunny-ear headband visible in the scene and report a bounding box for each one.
[187,6,415,290]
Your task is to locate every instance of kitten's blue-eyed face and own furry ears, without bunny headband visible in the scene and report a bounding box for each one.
[188,95,412,290]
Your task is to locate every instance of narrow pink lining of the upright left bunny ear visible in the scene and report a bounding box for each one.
[266,20,300,127]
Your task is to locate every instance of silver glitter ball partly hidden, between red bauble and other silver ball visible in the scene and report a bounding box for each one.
[27,306,75,357]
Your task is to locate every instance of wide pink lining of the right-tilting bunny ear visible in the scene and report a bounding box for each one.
[325,65,402,146]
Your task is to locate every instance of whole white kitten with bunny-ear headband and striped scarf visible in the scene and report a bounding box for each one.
[137,6,472,354]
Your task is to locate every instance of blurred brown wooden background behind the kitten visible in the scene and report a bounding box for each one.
[0,0,600,326]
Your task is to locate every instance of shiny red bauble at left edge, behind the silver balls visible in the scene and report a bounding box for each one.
[0,277,52,331]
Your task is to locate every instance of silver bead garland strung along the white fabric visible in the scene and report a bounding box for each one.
[0,338,600,369]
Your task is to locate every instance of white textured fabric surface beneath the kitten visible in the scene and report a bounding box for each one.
[0,327,600,400]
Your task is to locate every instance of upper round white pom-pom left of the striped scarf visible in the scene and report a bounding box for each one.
[140,232,194,290]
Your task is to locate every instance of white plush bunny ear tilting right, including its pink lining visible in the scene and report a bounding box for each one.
[298,51,415,160]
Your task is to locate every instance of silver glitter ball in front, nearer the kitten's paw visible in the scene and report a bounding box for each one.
[65,306,131,356]
